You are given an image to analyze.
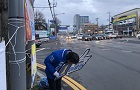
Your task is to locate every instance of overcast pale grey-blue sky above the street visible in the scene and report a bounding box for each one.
[34,0,140,25]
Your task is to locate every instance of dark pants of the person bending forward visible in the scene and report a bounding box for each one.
[47,77,61,90]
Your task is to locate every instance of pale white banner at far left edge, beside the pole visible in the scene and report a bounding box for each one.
[0,42,7,90]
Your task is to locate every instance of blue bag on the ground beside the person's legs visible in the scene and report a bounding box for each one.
[38,78,49,90]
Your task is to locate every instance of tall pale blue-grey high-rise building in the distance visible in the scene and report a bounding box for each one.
[73,14,89,31]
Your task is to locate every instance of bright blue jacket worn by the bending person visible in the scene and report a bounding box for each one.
[44,49,72,79]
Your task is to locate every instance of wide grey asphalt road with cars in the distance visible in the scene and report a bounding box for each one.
[37,39,140,90]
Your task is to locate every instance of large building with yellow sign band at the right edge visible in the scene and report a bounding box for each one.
[112,8,140,36]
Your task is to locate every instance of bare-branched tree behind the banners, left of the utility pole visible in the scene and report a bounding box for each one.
[34,10,47,30]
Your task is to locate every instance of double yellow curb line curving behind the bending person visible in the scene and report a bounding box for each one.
[37,63,87,90]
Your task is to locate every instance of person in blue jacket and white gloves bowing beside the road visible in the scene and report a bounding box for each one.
[44,49,79,90]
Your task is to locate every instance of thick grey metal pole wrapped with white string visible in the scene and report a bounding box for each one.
[9,0,26,90]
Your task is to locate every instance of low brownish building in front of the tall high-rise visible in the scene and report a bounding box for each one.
[82,23,98,34]
